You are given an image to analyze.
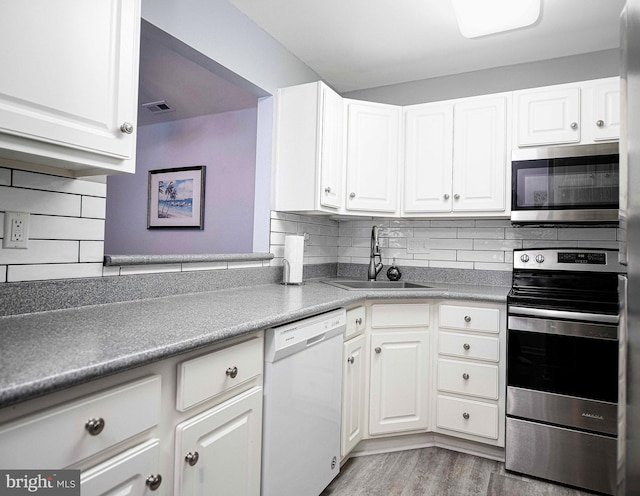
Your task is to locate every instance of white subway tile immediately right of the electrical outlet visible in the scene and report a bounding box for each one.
[29,215,104,241]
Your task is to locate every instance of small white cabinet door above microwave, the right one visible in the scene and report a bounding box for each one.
[590,78,620,141]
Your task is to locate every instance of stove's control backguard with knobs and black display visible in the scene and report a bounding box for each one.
[513,248,625,273]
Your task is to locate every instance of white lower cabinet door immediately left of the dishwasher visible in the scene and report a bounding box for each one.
[175,387,262,496]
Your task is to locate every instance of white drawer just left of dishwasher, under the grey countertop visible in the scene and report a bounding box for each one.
[176,338,263,412]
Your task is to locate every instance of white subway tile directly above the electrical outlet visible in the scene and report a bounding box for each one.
[0,186,81,217]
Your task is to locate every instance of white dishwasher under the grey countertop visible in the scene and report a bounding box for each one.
[262,309,346,496]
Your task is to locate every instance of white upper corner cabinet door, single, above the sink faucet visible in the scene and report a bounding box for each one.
[346,100,401,213]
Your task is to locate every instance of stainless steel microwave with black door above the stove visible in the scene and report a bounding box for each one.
[511,143,620,224]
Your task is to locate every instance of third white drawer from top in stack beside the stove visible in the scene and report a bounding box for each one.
[438,359,498,400]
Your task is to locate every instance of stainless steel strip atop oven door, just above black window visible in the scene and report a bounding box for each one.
[508,315,618,341]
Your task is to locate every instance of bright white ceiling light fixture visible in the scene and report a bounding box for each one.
[451,0,540,38]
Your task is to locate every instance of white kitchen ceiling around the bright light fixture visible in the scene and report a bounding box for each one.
[229,0,625,93]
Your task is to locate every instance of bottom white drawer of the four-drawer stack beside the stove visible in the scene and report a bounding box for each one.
[436,396,498,439]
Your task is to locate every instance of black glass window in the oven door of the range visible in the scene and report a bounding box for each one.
[507,330,618,402]
